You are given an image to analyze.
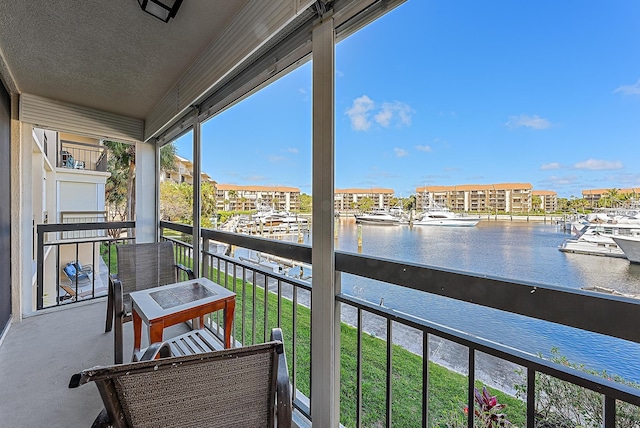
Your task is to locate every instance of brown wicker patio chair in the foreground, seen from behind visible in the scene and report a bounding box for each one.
[69,329,291,428]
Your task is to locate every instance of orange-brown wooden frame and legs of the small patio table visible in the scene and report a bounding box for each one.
[131,278,236,355]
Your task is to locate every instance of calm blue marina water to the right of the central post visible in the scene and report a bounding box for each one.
[336,219,640,382]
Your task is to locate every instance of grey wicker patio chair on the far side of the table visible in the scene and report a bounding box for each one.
[104,241,195,364]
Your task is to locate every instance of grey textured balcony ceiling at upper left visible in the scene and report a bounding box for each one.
[0,0,248,119]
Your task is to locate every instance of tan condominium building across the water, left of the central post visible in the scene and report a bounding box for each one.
[216,184,300,211]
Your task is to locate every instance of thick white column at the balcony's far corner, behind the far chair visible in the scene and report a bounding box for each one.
[136,142,160,243]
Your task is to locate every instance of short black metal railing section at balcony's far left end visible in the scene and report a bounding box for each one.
[36,221,135,310]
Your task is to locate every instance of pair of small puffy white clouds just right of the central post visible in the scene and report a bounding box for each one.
[345,95,414,131]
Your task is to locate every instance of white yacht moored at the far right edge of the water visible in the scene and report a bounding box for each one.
[558,217,640,258]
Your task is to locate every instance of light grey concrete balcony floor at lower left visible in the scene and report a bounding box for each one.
[0,298,186,428]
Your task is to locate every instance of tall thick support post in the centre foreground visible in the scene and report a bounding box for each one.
[311,12,340,427]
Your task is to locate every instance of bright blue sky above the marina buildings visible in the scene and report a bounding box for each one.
[177,0,640,197]
